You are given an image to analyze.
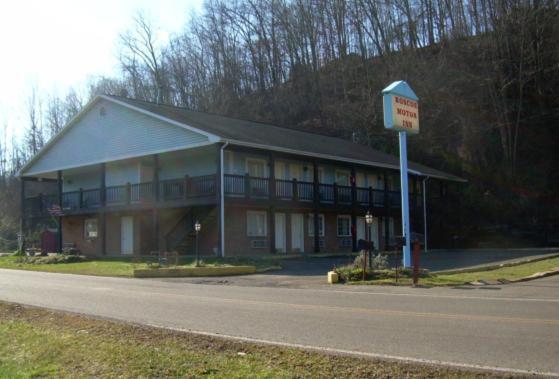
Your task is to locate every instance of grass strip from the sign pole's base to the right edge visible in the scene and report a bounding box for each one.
[349,257,559,286]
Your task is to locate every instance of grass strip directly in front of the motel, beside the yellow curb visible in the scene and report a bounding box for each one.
[0,256,281,277]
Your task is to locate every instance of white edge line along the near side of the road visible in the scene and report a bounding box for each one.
[148,323,559,378]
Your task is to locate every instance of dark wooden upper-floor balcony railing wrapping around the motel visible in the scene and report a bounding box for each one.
[25,174,422,216]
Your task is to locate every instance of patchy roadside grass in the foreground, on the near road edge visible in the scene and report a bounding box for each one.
[0,303,501,378]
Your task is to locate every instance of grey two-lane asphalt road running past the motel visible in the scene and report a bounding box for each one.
[0,270,559,376]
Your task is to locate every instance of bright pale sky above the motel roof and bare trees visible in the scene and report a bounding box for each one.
[0,0,203,144]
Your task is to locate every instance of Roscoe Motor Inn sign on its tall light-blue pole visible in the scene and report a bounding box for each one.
[382,80,419,267]
